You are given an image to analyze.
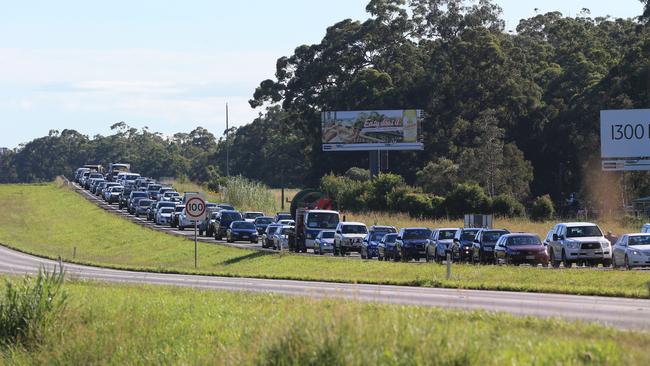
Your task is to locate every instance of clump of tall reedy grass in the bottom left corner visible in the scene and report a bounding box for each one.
[0,267,67,345]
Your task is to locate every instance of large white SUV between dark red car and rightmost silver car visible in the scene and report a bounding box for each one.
[548,222,612,268]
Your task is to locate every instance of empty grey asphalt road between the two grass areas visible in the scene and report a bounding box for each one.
[0,246,650,331]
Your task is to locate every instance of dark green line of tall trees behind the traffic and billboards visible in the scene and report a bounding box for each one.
[0,0,650,213]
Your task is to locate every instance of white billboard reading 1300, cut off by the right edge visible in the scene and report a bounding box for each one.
[600,109,650,158]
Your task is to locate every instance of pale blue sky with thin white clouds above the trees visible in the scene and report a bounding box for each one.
[0,0,642,148]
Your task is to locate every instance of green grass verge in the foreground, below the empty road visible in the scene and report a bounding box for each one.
[0,282,650,365]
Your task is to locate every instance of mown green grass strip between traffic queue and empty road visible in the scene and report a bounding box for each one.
[0,184,649,298]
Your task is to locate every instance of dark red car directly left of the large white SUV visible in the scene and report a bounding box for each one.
[494,233,549,267]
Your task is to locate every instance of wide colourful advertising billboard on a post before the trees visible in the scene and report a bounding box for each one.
[321,109,424,151]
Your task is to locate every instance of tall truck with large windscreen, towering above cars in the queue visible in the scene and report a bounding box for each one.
[289,208,340,253]
